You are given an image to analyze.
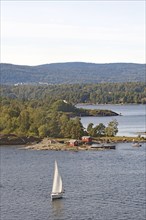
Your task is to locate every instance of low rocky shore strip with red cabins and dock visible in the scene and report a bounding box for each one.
[23,136,145,152]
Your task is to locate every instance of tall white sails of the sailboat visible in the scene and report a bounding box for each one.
[52,161,62,194]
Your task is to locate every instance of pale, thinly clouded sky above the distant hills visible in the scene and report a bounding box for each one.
[1,0,146,65]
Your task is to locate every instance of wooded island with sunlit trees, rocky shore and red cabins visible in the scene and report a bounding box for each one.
[0,99,144,151]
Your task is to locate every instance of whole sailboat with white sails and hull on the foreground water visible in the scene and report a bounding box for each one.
[51,160,63,201]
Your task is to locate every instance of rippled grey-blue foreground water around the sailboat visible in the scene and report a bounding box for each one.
[0,143,146,220]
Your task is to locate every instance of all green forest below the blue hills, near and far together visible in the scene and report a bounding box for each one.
[0,82,146,138]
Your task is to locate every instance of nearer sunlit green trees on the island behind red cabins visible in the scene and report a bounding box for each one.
[0,98,118,139]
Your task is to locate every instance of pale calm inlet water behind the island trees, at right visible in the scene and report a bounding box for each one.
[77,105,146,137]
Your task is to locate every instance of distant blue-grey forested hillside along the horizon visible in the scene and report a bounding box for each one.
[0,62,146,84]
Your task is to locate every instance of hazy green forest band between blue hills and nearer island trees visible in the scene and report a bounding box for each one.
[0,82,146,104]
